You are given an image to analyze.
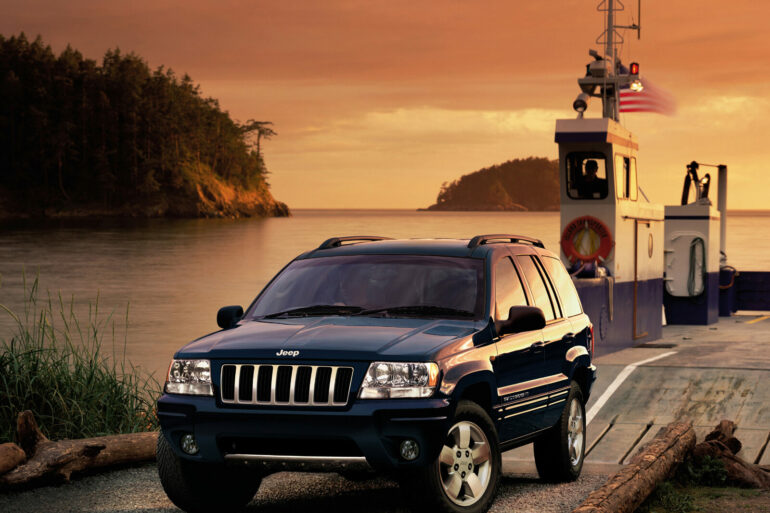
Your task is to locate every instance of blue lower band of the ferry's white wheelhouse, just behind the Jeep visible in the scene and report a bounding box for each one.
[575,278,663,356]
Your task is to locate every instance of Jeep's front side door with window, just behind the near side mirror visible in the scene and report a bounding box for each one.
[492,256,548,441]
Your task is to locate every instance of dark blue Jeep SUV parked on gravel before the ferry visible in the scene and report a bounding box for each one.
[158,235,596,513]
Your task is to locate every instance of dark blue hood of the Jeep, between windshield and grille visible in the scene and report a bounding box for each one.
[176,317,480,361]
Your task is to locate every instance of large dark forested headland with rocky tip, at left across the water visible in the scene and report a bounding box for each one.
[0,34,289,219]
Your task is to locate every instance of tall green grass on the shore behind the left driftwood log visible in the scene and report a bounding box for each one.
[0,278,161,443]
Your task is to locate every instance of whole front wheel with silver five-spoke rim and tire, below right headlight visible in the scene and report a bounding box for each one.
[401,401,501,513]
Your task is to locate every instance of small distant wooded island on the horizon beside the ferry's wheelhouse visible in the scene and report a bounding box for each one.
[421,157,559,211]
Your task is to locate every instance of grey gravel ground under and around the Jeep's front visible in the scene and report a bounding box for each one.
[0,464,607,513]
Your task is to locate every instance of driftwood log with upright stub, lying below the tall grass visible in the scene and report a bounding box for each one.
[0,411,158,487]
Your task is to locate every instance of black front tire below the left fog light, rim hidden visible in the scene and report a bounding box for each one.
[157,433,262,513]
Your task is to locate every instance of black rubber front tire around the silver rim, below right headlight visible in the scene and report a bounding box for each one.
[399,401,502,513]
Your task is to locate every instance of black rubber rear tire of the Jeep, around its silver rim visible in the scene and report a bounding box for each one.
[535,381,586,483]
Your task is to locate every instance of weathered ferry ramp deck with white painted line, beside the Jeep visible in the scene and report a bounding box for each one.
[503,312,770,474]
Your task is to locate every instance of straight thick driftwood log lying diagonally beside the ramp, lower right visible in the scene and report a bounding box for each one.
[573,422,695,513]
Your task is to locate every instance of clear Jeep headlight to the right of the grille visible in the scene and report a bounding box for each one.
[358,362,438,399]
